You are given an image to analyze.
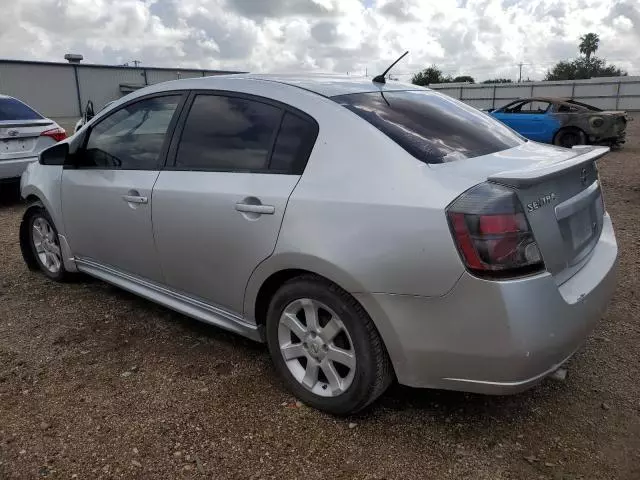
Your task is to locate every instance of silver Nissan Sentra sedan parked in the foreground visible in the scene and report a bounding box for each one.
[20,75,617,414]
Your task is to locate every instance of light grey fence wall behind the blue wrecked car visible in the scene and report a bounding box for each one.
[429,77,640,111]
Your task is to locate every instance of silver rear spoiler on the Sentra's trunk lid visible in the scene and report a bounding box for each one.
[488,145,610,188]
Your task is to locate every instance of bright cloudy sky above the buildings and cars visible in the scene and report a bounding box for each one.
[0,0,640,80]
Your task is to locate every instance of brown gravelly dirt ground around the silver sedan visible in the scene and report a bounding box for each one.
[0,115,640,480]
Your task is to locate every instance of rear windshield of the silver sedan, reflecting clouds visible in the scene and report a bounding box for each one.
[333,90,526,163]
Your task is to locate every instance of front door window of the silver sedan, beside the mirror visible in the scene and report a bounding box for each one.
[81,95,180,170]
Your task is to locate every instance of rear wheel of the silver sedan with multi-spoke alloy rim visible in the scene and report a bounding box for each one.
[266,275,394,415]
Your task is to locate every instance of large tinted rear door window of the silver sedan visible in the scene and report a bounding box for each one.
[176,95,282,171]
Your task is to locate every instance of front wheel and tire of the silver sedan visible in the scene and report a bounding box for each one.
[20,203,72,282]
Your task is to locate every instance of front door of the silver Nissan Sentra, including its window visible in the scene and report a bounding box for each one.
[61,93,187,282]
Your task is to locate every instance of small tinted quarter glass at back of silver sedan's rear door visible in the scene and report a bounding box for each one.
[269,112,318,175]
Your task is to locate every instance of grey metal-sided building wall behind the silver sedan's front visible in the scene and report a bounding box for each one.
[0,60,240,122]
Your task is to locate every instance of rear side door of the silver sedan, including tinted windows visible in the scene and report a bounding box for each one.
[153,92,318,314]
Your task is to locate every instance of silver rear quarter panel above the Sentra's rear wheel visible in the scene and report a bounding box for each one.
[245,84,463,315]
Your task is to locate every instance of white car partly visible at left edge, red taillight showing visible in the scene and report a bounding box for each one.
[0,95,67,181]
